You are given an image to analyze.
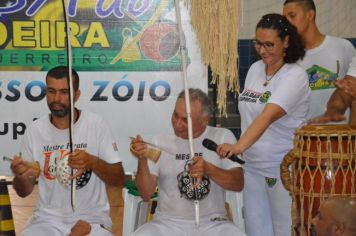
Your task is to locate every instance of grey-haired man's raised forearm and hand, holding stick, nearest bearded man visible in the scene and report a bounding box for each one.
[130,135,157,201]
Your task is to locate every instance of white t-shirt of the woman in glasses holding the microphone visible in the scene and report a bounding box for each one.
[239,60,310,177]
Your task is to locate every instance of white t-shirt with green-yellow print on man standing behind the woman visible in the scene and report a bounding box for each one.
[298,35,356,120]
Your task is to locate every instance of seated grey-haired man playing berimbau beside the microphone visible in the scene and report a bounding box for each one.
[131,89,245,236]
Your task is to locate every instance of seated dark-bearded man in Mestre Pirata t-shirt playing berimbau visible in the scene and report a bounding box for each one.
[11,66,124,236]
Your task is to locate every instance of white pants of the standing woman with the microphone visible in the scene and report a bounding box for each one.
[243,170,292,236]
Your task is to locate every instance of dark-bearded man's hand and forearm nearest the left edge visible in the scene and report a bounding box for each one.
[10,157,36,197]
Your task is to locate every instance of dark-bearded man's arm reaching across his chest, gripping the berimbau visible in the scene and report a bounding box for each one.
[68,149,124,186]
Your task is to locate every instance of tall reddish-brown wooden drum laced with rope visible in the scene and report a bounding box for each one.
[281,125,356,235]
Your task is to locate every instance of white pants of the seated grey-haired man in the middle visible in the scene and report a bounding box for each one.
[133,212,246,236]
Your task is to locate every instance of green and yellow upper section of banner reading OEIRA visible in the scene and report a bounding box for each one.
[0,0,189,71]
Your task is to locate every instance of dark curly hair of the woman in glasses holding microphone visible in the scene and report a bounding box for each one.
[256,13,305,63]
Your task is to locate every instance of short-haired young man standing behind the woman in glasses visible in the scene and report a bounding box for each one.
[283,0,356,124]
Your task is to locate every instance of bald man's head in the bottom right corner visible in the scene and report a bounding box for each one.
[312,197,356,236]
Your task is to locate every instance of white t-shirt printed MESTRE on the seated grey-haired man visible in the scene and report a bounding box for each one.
[149,126,240,220]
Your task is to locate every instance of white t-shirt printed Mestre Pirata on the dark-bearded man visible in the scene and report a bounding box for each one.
[22,111,121,226]
